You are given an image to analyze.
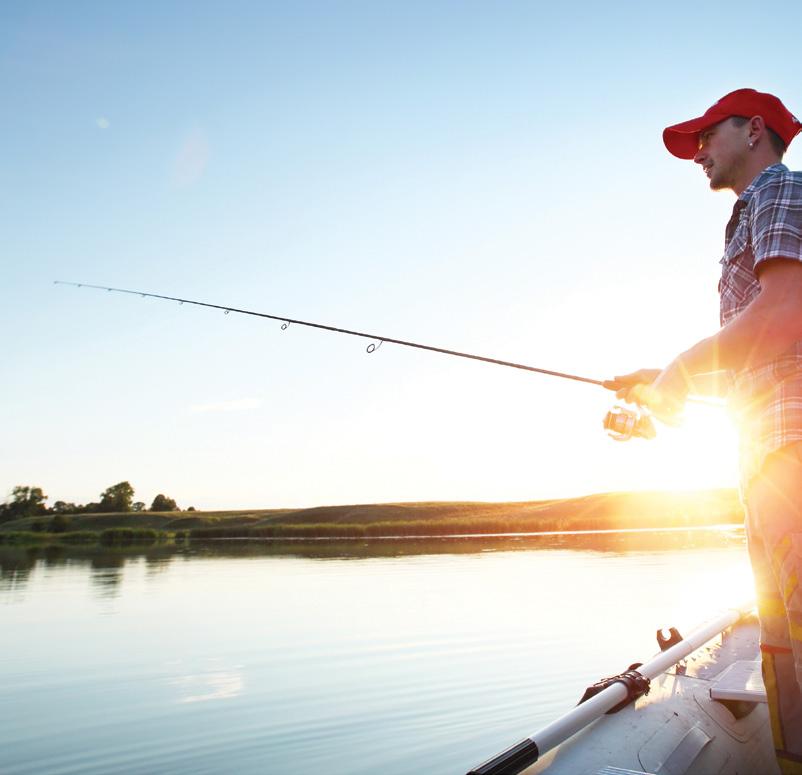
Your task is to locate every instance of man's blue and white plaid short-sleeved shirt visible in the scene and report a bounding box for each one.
[719,164,802,488]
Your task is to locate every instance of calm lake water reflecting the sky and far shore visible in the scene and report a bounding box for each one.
[0,529,751,775]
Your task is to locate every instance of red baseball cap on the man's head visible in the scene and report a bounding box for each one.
[663,89,802,159]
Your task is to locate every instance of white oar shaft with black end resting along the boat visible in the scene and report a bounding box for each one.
[468,602,754,775]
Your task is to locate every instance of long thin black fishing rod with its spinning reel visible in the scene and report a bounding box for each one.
[53,280,708,441]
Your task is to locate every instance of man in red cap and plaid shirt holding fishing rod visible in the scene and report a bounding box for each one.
[605,89,802,773]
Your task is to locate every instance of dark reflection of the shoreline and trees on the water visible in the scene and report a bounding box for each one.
[0,525,744,597]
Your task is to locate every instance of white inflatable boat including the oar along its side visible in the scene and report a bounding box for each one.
[468,603,779,775]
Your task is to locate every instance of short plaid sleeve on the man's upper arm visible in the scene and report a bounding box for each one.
[750,175,802,267]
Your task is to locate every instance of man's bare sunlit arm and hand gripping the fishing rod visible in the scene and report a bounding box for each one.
[630,259,802,413]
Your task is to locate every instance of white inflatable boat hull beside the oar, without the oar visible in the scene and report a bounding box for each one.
[525,619,779,775]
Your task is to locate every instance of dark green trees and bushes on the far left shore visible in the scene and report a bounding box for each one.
[0,482,195,522]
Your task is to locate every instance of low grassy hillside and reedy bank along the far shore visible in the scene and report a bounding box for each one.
[0,489,743,544]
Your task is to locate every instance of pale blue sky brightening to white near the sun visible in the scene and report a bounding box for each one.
[0,0,802,509]
